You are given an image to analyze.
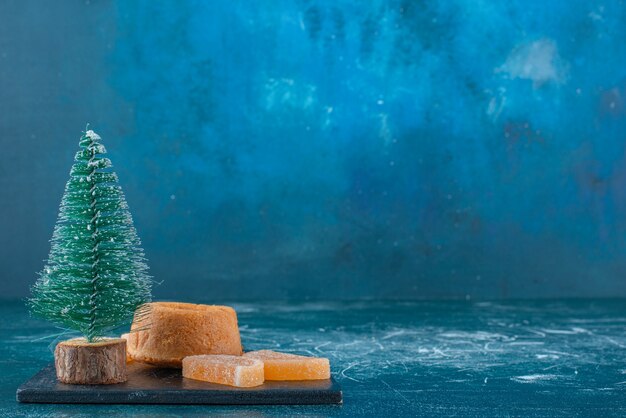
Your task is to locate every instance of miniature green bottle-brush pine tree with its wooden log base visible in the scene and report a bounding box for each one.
[29,130,151,384]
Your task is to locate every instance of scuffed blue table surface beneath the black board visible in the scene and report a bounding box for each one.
[0,300,626,417]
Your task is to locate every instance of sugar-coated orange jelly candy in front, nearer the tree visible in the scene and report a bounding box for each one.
[183,354,264,388]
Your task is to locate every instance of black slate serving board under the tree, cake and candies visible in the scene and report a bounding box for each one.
[17,363,342,405]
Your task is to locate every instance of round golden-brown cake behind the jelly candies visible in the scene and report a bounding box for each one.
[126,302,242,367]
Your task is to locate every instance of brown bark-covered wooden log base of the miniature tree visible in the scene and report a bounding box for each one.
[54,338,128,385]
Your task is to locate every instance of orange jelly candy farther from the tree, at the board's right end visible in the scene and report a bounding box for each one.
[244,350,330,380]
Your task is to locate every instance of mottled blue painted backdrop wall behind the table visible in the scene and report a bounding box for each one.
[0,0,626,301]
